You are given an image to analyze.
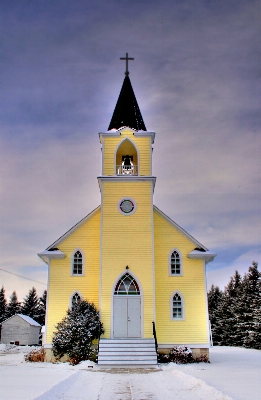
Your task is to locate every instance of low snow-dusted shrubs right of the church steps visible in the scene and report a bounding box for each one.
[158,346,209,364]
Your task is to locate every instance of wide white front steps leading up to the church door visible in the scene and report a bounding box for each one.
[98,339,157,366]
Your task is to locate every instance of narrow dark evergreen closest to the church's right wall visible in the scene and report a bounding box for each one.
[208,285,223,343]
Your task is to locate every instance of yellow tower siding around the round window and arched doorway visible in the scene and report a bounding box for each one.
[101,181,154,338]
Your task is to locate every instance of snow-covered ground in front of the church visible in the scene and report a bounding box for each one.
[0,345,261,400]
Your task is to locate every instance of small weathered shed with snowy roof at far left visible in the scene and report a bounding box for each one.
[1,314,41,345]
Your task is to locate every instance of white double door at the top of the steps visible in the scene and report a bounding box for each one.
[113,296,141,338]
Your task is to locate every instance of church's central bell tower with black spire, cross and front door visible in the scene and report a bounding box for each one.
[98,53,156,338]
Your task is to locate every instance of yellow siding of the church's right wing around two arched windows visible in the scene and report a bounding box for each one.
[154,210,208,344]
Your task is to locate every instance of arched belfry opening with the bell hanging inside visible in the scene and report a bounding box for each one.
[116,139,138,175]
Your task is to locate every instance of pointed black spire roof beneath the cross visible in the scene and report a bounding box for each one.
[108,73,146,131]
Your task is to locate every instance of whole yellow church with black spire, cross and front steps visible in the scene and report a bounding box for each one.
[38,54,215,365]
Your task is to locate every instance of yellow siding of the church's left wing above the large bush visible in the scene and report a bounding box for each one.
[46,209,100,343]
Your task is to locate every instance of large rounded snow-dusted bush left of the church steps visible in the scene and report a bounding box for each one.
[52,300,104,365]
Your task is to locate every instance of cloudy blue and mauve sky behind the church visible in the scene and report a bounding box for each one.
[0,0,261,299]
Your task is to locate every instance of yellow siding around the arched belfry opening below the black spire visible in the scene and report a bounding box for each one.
[103,130,151,176]
